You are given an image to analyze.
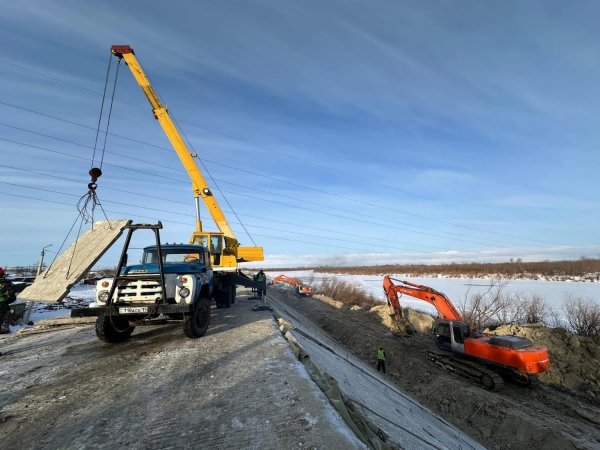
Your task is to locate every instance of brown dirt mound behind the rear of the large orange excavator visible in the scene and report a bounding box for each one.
[492,325,600,396]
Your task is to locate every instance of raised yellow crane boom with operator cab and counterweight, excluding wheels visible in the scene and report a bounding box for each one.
[111,45,264,270]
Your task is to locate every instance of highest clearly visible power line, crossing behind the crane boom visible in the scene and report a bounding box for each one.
[0,98,560,245]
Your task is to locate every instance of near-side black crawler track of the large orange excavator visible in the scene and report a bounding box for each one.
[427,351,504,391]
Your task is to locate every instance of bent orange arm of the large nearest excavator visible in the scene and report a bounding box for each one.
[383,276,463,322]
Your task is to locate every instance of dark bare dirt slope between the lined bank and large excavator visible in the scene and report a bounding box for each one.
[281,294,600,450]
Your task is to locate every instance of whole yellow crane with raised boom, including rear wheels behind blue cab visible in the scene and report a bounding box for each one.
[111,45,264,308]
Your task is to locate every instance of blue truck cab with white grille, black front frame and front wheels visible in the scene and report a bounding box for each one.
[71,220,222,344]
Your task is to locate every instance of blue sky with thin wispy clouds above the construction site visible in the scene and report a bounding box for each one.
[0,0,600,267]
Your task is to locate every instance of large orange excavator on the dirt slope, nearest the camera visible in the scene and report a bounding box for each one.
[383,276,550,390]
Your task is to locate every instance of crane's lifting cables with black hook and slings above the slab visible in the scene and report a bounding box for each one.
[44,53,121,278]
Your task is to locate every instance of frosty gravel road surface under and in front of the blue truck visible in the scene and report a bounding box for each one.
[0,290,364,450]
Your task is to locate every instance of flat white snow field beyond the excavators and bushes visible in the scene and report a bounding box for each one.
[265,270,600,314]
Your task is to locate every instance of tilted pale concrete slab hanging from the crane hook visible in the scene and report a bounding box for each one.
[18,220,131,303]
